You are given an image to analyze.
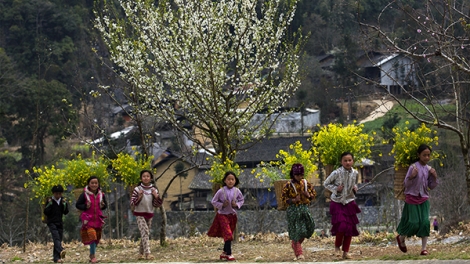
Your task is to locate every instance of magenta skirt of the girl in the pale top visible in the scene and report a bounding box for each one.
[330,201,361,236]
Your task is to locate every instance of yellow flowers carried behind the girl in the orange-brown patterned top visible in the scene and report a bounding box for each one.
[252,141,317,183]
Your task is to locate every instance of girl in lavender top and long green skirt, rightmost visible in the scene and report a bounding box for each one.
[396,144,438,255]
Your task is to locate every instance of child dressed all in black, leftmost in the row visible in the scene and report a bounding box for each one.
[44,185,69,263]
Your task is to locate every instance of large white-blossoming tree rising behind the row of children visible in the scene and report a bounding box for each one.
[95,0,304,161]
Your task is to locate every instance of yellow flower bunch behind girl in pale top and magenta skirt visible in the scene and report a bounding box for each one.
[311,124,374,167]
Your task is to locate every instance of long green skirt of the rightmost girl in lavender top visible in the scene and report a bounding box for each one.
[397,201,431,237]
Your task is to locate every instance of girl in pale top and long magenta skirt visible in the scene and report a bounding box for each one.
[323,152,361,259]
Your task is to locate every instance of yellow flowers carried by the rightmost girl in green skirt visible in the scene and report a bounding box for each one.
[389,121,442,168]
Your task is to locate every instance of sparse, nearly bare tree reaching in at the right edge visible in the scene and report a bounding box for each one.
[360,0,470,202]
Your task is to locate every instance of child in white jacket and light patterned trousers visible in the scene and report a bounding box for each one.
[131,170,163,259]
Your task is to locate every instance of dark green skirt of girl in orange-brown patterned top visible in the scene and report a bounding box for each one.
[286,204,315,241]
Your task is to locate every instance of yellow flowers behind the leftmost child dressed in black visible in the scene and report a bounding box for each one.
[24,165,67,198]
